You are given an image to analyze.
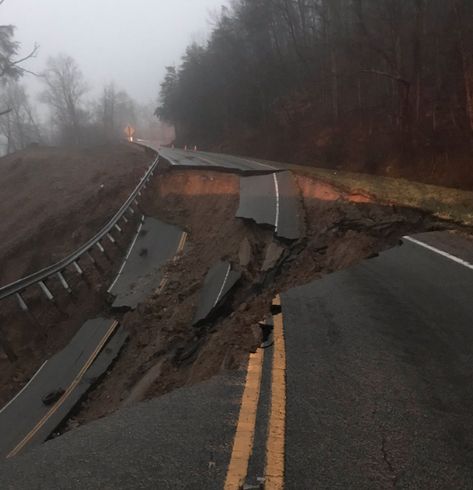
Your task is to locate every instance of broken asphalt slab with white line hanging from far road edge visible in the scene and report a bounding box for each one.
[236,171,302,240]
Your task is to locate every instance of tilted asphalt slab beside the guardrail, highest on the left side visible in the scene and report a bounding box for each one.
[108,218,187,309]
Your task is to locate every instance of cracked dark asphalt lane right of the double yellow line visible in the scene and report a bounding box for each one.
[282,237,473,490]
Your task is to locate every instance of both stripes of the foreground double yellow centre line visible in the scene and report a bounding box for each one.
[224,296,286,490]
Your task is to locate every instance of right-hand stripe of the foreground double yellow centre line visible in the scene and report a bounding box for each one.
[264,296,286,490]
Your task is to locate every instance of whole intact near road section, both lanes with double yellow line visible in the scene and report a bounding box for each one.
[0,231,473,489]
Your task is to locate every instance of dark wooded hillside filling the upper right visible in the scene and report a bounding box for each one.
[156,0,473,188]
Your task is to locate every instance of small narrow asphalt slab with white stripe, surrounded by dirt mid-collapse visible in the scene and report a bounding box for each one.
[192,261,241,325]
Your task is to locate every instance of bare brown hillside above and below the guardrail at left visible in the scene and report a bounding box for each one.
[0,144,152,405]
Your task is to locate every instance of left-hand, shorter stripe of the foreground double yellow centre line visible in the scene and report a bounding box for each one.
[224,349,264,490]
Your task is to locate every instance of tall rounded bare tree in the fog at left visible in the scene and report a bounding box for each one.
[41,54,88,145]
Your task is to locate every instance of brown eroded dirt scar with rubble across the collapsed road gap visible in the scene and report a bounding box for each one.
[60,169,437,426]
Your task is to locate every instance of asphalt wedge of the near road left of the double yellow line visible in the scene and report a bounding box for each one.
[0,371,245,490]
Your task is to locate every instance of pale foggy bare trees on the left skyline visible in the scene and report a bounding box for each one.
[0,0,172,155]
